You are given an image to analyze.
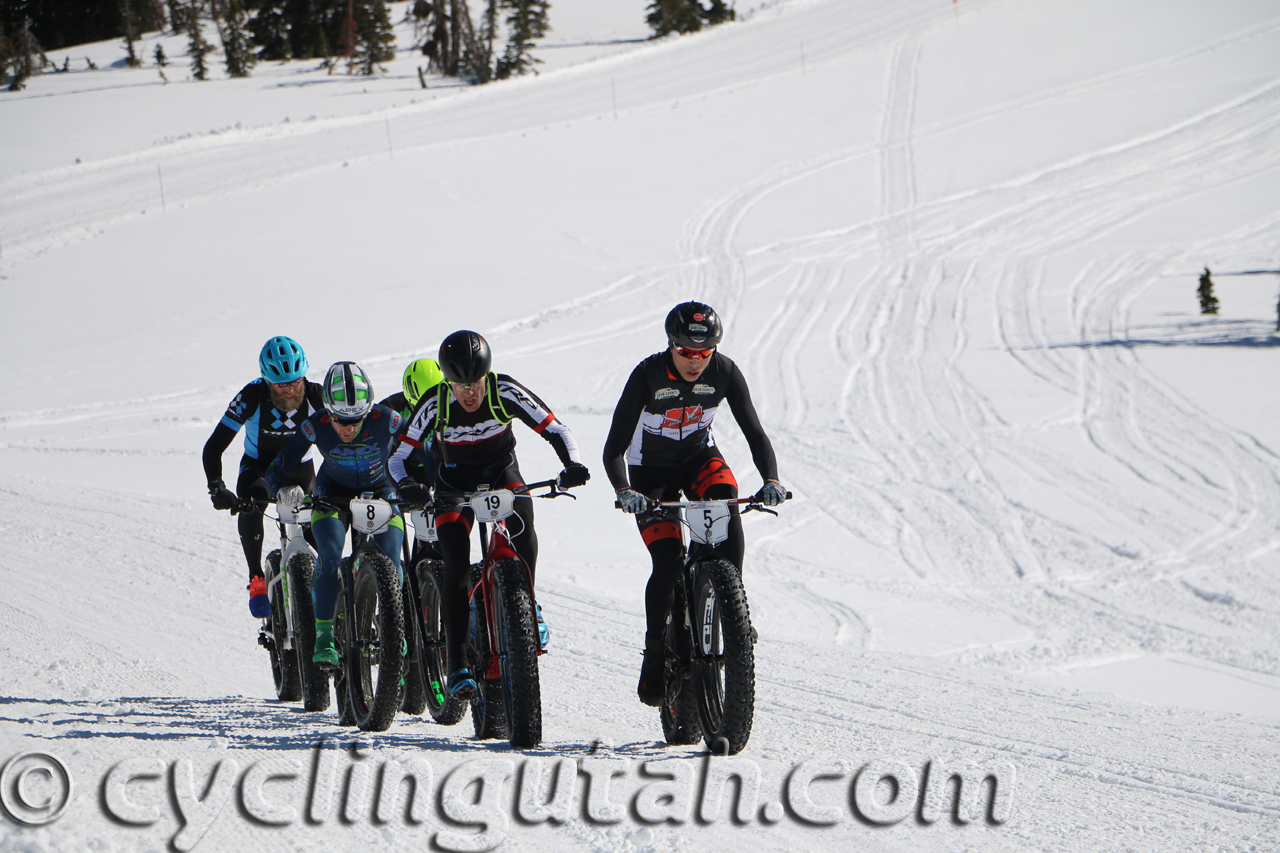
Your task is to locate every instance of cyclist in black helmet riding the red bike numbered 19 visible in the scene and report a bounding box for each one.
[388,330,591,699]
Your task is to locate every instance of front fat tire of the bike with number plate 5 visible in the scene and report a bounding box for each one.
[691,560,755,756]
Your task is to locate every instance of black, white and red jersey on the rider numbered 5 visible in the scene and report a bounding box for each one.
[604,350,778,489]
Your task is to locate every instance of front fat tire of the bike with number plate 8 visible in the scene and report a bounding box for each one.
[347,552,404,731]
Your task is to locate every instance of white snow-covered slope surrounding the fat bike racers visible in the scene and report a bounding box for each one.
[0,0,1280,853]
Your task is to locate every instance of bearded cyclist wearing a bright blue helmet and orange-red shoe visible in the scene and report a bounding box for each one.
[202,336,321,619]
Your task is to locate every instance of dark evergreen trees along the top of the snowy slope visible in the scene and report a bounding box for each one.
[0,0,736,88]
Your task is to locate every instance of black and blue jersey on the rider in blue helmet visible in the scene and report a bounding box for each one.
[202,378,324,482]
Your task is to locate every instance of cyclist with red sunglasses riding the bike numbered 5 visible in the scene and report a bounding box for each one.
[604,302,786,706]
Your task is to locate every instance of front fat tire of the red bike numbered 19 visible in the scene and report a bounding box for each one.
[494,560,543,749]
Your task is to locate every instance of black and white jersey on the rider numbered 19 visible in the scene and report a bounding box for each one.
[387,373,582,483]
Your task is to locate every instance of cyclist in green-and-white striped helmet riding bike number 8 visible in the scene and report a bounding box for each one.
[266,361,404,666]
